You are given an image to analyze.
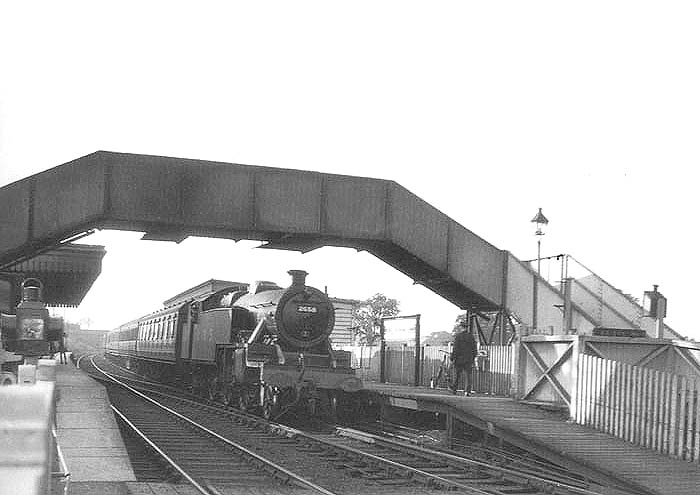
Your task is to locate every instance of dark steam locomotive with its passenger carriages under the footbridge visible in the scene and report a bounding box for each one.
[105,270,362,417]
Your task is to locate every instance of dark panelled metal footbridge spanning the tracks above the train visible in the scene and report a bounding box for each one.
[0,151,595,333]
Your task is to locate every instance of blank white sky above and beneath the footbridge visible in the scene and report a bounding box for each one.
[0,1,700,338]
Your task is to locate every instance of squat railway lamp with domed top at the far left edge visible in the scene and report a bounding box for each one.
[0,278,65,385]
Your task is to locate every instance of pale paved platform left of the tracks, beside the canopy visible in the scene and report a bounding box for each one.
[56,360,136,486]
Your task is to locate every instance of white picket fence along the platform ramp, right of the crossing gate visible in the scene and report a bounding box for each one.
[572,354,700,463]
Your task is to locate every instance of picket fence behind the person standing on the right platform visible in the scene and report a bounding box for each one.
[343,345,513,396]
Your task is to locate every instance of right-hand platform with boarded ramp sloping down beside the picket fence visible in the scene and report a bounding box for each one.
[365,383,700,495]
